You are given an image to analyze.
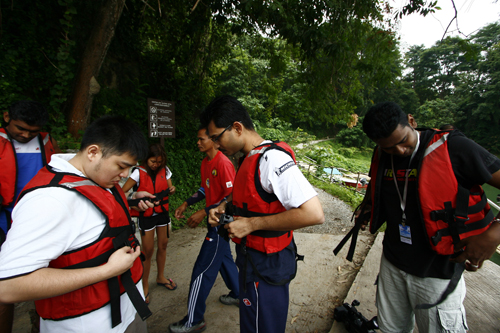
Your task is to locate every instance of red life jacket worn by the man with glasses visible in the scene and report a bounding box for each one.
[233,142,295,254]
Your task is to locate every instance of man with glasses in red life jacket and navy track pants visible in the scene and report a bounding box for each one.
[201,96,324,332]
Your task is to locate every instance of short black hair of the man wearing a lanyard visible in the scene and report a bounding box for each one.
[363,102,410,140]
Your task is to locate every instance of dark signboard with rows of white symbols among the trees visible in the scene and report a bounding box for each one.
[148,98,175,146]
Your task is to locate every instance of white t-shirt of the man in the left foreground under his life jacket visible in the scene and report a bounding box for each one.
[0,154,144,333]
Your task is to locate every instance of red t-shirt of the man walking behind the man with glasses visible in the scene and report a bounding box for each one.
[201,151,236,207]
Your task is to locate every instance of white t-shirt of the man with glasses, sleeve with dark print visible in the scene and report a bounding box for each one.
[259,140,318,210]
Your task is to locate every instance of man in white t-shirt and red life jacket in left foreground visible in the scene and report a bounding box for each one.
[0,116,154,333]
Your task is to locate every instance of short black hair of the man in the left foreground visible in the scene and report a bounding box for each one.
[80,116,148,160]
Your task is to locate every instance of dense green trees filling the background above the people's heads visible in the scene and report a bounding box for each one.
[0,0,500,152]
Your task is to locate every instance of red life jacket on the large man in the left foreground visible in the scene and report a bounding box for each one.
[17,167,149,327]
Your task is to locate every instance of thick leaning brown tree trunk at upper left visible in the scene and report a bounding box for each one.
[68,0,125,138]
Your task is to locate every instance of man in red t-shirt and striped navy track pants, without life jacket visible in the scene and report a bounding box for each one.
[169,127,239,333]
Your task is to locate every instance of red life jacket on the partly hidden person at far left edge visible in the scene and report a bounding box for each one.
[0,127,55,206]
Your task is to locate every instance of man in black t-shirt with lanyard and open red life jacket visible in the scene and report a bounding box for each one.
[356,102,500,332]
